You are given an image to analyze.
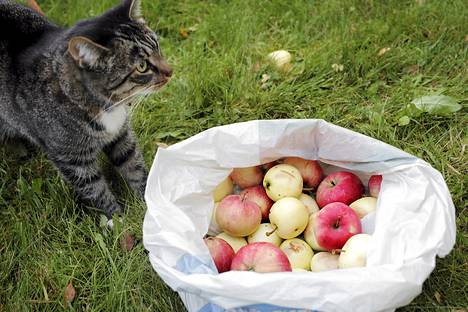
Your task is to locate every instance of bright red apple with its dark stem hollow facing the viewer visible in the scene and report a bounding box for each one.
[315,202,361,250]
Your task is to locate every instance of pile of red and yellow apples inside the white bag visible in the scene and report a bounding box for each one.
[204,157,382,273]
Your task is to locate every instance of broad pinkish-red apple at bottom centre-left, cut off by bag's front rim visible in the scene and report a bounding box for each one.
[231,242,292,273]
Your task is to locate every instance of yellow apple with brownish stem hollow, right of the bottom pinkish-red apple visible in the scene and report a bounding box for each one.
[280,238,314,270]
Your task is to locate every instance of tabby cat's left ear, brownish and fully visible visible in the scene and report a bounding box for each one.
[68,36,109,67]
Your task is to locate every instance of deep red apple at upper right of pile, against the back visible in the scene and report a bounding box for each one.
[315,171,364,207]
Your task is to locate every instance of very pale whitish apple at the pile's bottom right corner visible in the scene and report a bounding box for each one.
[338,234,371,269]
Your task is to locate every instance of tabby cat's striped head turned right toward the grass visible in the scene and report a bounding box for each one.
[67,0,172,103]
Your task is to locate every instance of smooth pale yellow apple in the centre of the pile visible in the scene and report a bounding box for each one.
[269,197,309,239]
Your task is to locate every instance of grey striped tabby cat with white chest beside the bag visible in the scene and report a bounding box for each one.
[0,0,172,218]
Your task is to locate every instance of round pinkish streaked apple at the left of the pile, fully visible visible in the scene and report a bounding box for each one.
[215,195,262,237]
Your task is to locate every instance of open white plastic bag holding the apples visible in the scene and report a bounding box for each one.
[143,120,455,312]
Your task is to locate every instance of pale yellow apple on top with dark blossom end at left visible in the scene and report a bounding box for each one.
[263,164,303,201]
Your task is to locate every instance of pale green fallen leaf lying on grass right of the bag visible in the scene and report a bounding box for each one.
[411,95,462,115]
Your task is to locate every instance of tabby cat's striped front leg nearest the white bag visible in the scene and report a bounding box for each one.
[104,128,148,197]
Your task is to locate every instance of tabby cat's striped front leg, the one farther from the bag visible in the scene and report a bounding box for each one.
[49,154,122,219]
